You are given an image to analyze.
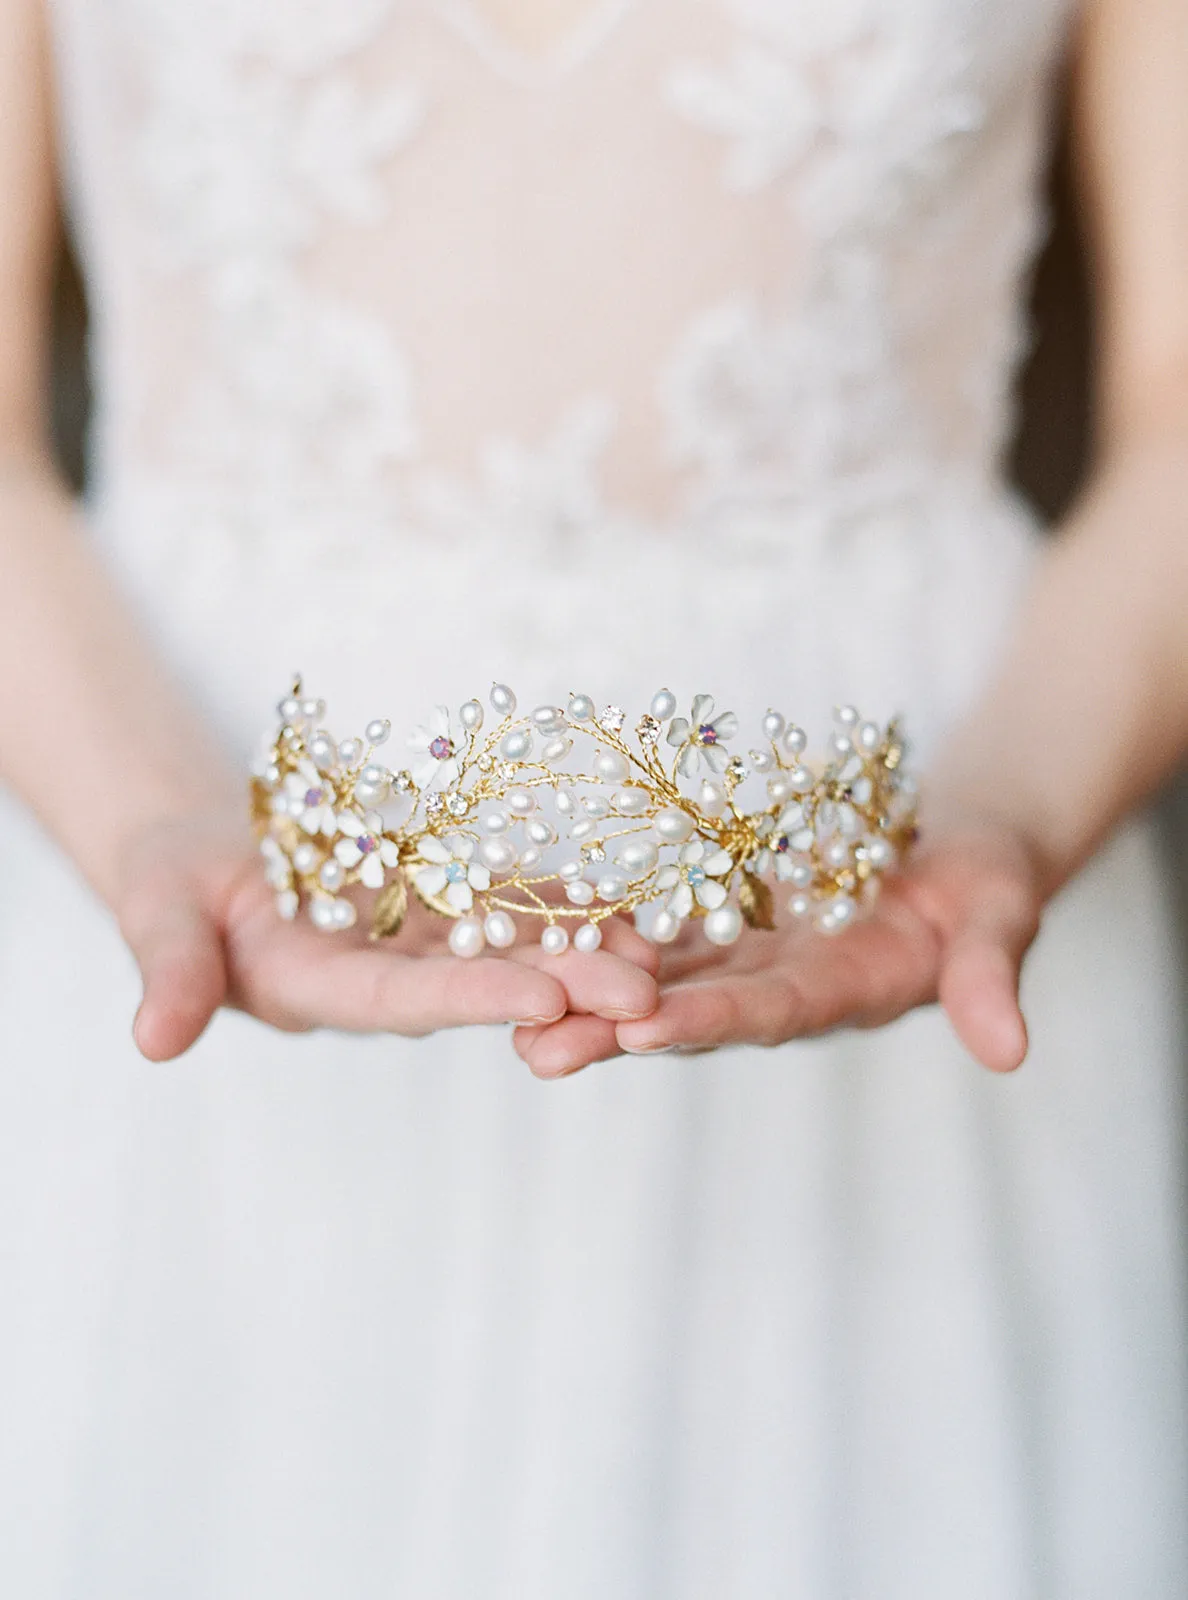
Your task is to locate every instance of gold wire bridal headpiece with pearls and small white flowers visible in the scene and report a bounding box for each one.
[253,680,916,957]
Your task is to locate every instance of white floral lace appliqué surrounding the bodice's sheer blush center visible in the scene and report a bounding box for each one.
[61,0,1082,569]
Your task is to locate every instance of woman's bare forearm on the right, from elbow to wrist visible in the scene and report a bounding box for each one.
[932,422,1188,893]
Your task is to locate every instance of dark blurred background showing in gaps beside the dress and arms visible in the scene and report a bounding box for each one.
[44,75,1188,1017]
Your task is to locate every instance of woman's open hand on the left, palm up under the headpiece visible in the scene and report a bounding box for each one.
[117,819,658,1061]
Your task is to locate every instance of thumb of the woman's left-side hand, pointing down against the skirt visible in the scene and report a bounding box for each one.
[120,877,227,1061]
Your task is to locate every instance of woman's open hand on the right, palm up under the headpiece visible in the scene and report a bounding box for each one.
[516,821,1041,1077]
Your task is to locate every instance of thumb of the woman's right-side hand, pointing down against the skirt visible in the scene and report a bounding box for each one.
[940,886,1039,1072]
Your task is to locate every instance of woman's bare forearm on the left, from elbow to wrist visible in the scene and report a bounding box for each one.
[0,456,235,904]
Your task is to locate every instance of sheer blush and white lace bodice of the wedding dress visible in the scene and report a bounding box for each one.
[46,0,1068,576]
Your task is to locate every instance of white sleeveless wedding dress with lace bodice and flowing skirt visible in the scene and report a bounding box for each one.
[0,0,1188,1600]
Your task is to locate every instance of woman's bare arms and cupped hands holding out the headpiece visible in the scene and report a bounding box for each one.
[0,0,1188,1077]
